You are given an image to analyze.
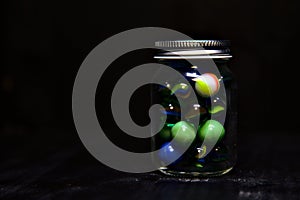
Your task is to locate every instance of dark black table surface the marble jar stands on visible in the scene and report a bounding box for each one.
[0,133,300,200]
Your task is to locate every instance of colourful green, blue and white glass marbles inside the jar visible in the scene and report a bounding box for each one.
[155,73,225,168]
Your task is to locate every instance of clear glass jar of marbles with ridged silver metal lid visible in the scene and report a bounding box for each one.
[152,40,237,176]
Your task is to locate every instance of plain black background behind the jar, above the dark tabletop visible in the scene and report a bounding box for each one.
[0,0,300,198]
